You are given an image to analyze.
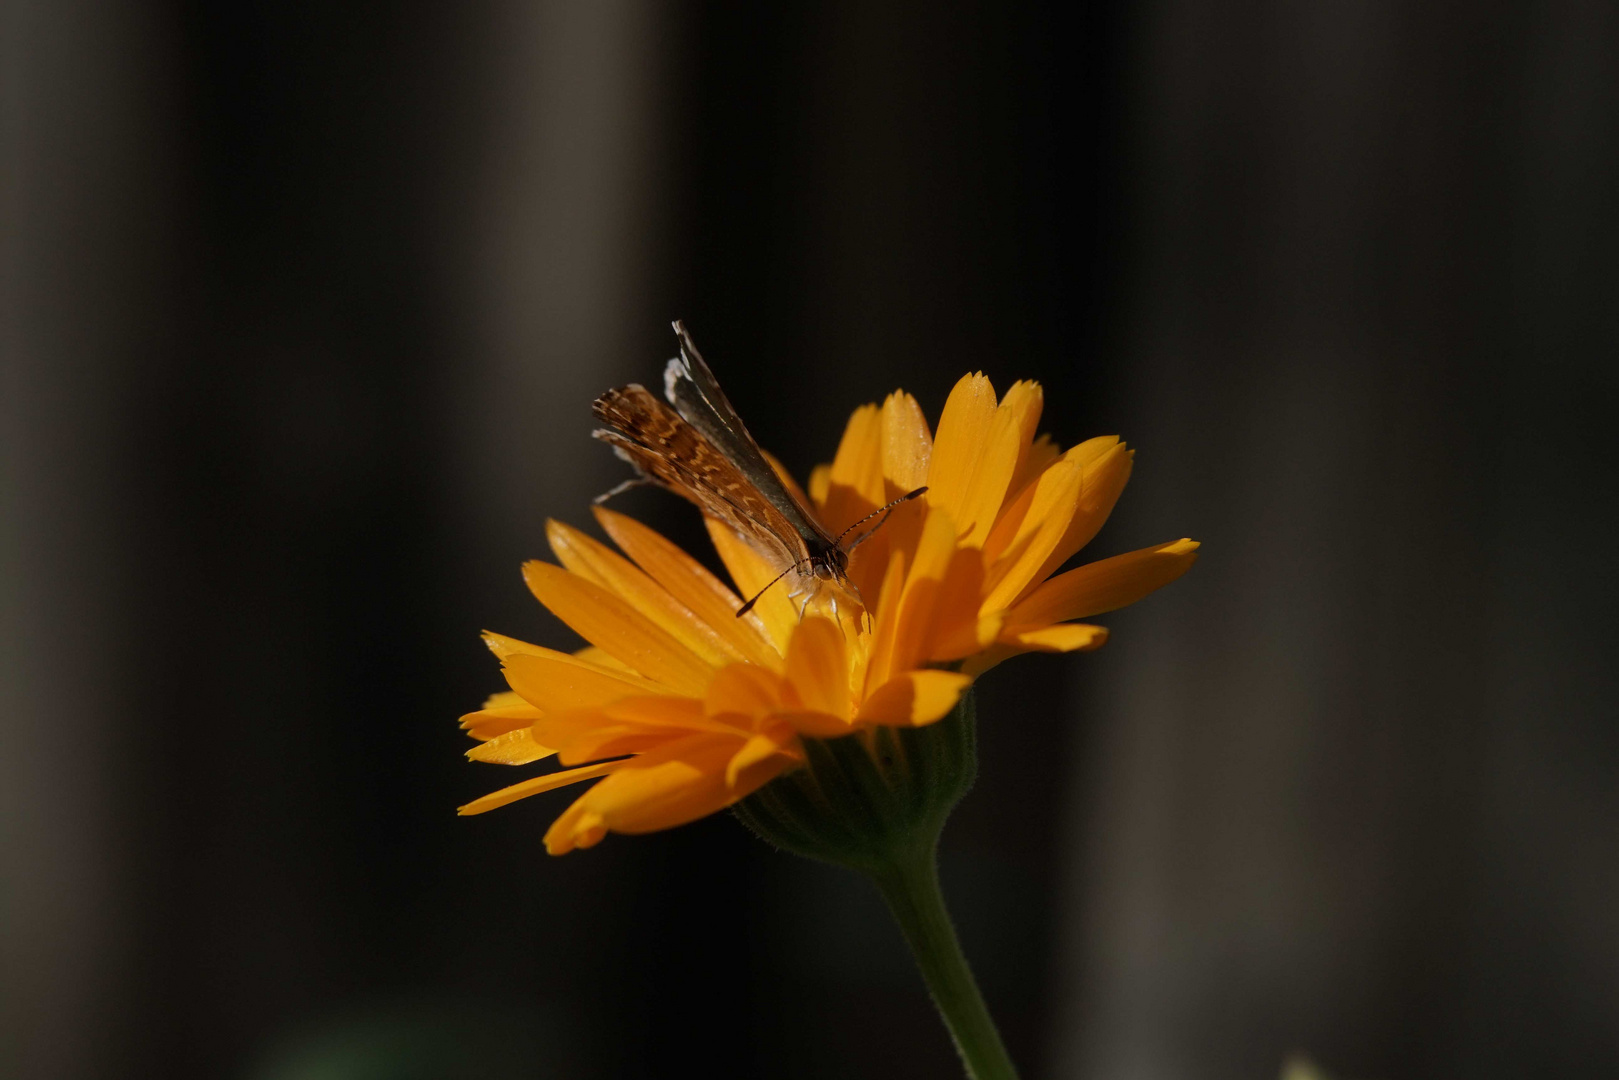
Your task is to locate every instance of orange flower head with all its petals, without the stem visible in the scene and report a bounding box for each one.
[461,376,1196,853]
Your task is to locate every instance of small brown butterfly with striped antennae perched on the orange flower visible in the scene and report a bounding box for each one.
[591,319,928,617]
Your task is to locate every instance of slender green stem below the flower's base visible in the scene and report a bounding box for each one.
[866,844,1017,1080]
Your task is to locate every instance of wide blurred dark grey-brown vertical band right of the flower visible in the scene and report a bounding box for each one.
[1057,3,1619,1080]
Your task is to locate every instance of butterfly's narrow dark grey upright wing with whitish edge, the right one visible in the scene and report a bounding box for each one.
[664,321,837,555]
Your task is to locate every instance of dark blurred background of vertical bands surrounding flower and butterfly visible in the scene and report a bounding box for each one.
[0,0,1619,1080]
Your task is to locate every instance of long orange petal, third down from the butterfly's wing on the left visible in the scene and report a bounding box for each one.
[520,560,714,696]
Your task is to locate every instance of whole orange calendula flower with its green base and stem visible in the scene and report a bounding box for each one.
[461,365,1198,1080]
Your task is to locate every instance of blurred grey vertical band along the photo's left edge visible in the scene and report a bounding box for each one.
[0,0,173,1080]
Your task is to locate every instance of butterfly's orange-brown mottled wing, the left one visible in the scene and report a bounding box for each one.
[591,384,810,570]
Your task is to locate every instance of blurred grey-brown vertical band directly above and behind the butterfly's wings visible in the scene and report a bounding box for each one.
[461,0,674,581]
